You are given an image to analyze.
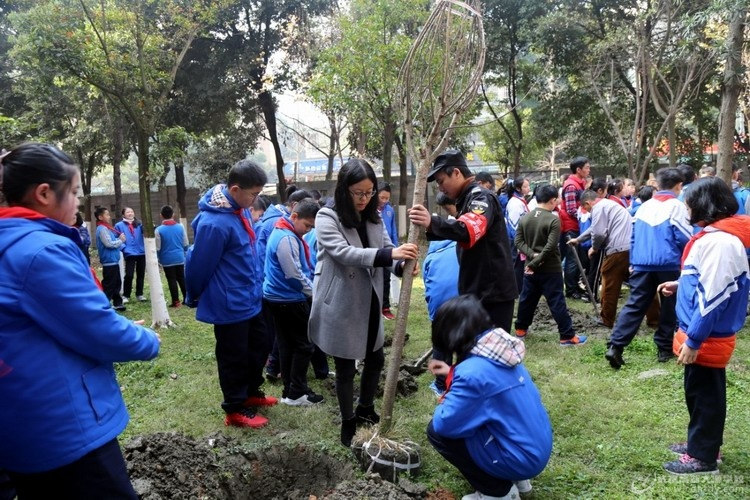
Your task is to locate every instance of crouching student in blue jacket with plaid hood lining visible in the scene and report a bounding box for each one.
[427,295,552,500]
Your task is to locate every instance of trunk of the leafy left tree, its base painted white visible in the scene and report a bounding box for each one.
[136,129,173,328]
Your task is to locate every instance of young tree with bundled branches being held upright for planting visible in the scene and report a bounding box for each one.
[380,0,485,436]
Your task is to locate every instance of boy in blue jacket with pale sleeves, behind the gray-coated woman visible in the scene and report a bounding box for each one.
[263,199,323,406]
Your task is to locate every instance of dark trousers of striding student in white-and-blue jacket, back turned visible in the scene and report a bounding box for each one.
[609,271,680,352]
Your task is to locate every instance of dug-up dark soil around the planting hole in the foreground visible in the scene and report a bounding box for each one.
[124,433,425,500]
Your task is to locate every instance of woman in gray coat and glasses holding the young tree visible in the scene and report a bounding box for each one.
[309,159,417,446]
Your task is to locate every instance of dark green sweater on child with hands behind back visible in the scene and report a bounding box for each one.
[515,208,562,273]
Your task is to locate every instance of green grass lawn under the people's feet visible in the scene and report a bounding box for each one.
[117,279,750,499]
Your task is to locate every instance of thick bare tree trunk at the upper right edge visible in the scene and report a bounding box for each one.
[716,5,747,186]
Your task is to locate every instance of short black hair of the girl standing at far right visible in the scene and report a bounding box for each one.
[685,177,740,225]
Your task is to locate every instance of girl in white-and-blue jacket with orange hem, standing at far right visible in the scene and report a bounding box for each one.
[658,177,750,474]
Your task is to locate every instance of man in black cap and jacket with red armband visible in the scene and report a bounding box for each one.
[409,150,518,332]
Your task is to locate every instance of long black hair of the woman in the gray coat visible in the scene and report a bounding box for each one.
[333,158,380,227]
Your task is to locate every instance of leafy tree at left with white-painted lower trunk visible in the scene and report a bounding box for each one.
[14,0,222,326]
